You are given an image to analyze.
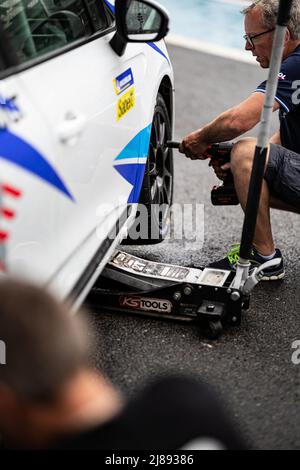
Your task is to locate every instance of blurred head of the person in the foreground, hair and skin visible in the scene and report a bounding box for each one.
[0,280,120,448]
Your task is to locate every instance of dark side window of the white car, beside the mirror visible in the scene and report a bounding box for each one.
[0,0,108,63]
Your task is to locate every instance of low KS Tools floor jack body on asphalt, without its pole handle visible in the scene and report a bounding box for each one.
[92,251,277,339]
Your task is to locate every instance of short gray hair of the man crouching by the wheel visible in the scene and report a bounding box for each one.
[241,0,300,40]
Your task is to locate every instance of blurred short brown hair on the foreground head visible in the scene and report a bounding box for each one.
[0,279,90,404]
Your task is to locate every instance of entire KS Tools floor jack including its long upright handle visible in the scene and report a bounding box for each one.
[92,0,292,339]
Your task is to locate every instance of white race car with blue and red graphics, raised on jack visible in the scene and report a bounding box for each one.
[0,0,174,305]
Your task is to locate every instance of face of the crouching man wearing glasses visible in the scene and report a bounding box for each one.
[245,7,274,69]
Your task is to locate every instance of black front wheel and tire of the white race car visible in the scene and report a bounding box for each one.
[125,93,174,245]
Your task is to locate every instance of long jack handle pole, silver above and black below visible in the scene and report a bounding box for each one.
[240,0,293,264]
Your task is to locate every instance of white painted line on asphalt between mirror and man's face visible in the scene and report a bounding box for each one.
[166,34,257,65]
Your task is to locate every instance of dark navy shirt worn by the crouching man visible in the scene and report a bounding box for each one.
[256,45,300,154]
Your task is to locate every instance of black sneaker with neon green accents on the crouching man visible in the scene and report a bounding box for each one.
[209,243,285,281]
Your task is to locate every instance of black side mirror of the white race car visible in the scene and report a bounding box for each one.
[110,0,169,56]
